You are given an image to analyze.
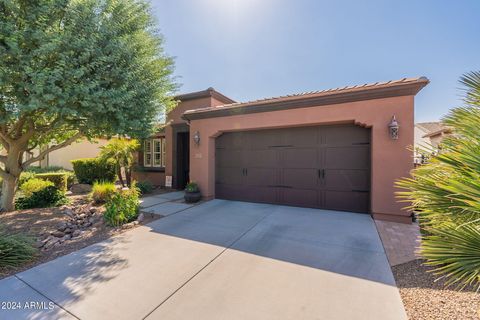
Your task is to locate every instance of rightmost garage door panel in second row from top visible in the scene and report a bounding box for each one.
[325,146,370,169]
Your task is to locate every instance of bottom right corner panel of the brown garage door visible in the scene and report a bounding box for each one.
[325,191,370,212]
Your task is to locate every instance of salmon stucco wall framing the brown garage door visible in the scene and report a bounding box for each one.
[190,95,414,223]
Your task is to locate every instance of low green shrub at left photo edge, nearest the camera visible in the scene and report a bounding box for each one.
[0,229,37,269]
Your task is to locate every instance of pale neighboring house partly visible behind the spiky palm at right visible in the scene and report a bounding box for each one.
[414,121,452,165]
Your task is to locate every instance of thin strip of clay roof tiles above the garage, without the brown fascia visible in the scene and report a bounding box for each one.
[184,77,430,116]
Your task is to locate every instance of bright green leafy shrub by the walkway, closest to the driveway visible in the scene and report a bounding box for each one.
[103,183,140,227]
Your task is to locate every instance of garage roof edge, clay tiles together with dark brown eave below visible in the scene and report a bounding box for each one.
[183,77,430,120]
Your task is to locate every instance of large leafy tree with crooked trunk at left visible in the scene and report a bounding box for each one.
[0,0,176,210]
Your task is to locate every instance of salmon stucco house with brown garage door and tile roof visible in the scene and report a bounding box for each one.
[135,77,429,223]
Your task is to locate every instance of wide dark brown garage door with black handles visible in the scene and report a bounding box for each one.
[215,125,370,212]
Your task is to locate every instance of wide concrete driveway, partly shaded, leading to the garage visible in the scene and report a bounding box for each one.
[0,200,406,320]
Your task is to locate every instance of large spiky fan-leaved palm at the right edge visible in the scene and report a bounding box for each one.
[398,72,480,288]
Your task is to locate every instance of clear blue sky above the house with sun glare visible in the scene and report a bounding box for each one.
[152,0,480,122]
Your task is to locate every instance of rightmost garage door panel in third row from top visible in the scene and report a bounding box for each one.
[325,169,370,191]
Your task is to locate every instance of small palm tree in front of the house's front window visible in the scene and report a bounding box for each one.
[100,138,140,187]
